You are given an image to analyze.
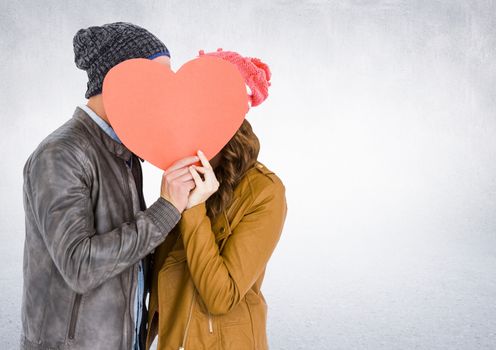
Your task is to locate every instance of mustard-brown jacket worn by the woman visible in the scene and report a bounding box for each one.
[147,162,287,350]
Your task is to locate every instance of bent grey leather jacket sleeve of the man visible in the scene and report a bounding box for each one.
[24,145,181,294]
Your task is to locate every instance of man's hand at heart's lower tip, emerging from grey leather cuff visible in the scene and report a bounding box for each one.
[160,156,200,213]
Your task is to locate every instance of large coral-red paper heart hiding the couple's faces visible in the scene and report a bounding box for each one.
[103,56,248,170]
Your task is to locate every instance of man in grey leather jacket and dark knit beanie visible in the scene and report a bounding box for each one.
[21,22,198,350]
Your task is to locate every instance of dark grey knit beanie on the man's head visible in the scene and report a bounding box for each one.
[73,22,170,98]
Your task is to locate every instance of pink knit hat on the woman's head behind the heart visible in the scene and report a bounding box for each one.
[199,48,271,107]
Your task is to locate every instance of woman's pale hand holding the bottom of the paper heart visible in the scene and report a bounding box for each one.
[186,151,219,209]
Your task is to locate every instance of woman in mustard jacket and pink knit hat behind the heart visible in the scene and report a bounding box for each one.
[147,49,287,350]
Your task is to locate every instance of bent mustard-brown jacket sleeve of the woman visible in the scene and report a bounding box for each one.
[179,182,287,315]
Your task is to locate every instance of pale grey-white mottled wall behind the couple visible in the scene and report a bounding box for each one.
[0,0,496,350]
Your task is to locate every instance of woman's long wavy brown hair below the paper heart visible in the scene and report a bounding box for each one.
[206,119,260,219]
